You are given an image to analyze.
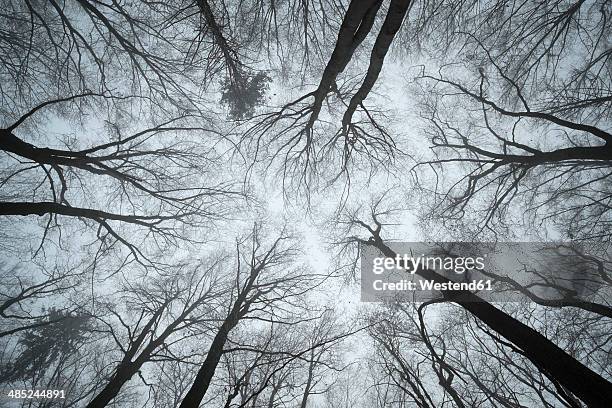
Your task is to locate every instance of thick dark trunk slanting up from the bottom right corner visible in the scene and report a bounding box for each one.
[367,236,612,407]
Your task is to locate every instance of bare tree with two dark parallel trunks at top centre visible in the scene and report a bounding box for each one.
[242,0,410,184]
